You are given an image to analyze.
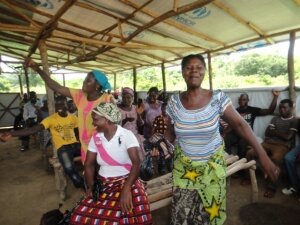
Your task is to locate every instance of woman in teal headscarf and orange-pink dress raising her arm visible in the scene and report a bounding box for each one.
[25,58,112,163]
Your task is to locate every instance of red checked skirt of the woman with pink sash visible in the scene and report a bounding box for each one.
[69,176,152,225]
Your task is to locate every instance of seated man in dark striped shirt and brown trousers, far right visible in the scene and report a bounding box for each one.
[246,99,297,198]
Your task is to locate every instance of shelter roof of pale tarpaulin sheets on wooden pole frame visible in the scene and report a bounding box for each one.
[0,0,300,104]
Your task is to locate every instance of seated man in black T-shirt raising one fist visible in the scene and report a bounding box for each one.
[223,90,280,158]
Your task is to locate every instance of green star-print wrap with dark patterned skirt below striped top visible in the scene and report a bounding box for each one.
[171,146,226,225]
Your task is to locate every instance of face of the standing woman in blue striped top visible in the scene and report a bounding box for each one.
[182,58,205,88]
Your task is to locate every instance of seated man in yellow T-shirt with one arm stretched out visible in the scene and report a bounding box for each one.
[0,96,84,188]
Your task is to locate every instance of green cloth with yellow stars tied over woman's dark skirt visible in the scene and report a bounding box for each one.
[172,146,226,225]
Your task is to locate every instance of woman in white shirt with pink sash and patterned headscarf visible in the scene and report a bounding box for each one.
[70,103,152,225]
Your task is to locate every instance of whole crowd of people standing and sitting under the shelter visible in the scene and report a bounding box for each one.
[0,55,300,225]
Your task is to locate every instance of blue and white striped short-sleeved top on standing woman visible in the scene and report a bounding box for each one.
[167,90,231,162]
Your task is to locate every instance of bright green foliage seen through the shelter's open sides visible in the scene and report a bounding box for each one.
[0,54,300,93]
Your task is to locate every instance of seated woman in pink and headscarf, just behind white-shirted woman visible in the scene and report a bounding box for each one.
[119,87,144,157]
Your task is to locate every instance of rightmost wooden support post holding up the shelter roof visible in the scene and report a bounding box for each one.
[288,31,296,103]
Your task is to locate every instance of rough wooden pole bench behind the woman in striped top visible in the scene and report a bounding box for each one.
[146,155,258,211]
